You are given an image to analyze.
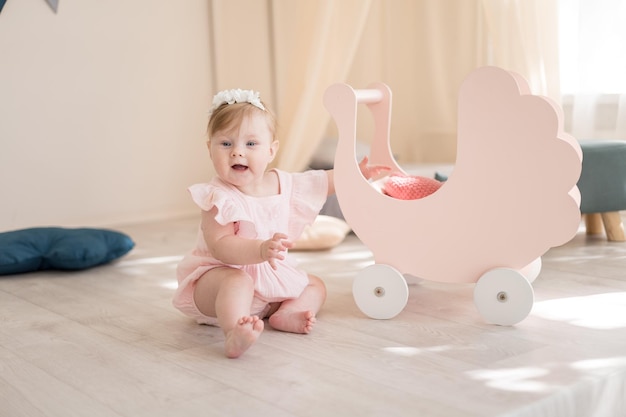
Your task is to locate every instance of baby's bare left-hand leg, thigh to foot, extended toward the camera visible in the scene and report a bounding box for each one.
[193,267,264,358]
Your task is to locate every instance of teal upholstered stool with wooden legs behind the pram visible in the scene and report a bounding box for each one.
[578,140,626,241]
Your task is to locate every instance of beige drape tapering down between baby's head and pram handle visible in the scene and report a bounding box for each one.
[273,0,371,171]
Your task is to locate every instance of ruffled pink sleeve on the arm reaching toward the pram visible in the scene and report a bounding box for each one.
[289,170,328,239]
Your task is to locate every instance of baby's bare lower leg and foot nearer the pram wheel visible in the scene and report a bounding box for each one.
[269,275,326,333]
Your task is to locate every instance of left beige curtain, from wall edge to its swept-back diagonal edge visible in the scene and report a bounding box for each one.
[209,0,372,171]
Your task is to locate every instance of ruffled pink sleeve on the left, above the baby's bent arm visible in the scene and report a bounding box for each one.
[189,183,253,231]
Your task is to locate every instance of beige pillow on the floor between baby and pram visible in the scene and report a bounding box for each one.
[292,215,350,250]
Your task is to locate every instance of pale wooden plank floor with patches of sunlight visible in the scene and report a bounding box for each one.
[0,213,626,417]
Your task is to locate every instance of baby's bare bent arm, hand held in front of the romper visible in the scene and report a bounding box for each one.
[201,207,293,269]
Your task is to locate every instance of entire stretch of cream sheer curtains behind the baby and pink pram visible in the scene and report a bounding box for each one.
[211,0,560,170]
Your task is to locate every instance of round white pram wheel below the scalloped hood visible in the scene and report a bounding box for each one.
[474,268,535,326]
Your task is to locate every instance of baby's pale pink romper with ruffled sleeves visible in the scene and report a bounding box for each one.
[172,170,328,325]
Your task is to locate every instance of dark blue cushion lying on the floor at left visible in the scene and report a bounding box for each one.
[0,227,135,275]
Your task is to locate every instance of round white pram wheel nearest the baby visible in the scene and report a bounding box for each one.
[352,264,409,319]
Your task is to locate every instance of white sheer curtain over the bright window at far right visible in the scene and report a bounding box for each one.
[560,0,626,140]
